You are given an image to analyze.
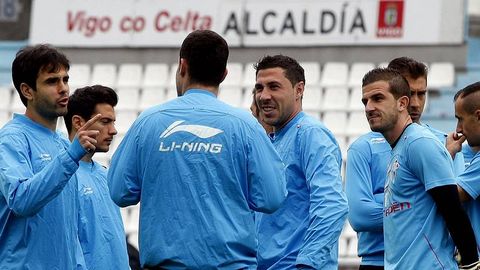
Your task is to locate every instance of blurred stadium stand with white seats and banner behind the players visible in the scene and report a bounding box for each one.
[0,0,480,269]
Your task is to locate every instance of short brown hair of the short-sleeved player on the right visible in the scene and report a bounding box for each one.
[362,68,410,99]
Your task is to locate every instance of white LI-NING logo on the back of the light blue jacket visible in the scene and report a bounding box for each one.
[158,120,223,154]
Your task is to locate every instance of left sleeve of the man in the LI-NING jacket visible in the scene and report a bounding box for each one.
[107,124,141,207]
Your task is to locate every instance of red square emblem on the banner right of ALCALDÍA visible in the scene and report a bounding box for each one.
[377,0,403,38]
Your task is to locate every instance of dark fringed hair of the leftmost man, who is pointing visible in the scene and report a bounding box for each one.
[12,44,70,106]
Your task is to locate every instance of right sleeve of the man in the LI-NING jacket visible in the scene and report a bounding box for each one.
[247,127,287,213]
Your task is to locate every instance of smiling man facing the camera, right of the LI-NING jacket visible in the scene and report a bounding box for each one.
[255,55,348,270]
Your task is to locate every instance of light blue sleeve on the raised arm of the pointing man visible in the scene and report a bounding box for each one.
[0,135,78,217]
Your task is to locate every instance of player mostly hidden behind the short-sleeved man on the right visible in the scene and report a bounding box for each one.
[345,57,464,270]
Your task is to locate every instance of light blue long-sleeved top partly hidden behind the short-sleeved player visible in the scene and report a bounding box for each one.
[345,132,392,266]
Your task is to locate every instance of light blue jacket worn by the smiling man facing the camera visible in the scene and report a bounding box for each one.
[257,112,348,270]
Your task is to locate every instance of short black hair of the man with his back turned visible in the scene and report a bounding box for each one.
[180,30,229,86]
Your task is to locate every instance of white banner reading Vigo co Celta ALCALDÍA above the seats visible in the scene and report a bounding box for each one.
[30,0,465,47]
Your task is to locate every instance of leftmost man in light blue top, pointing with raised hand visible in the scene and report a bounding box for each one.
[0,45,100,269]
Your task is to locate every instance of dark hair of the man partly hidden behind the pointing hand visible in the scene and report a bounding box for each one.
[63,85,118,133]
